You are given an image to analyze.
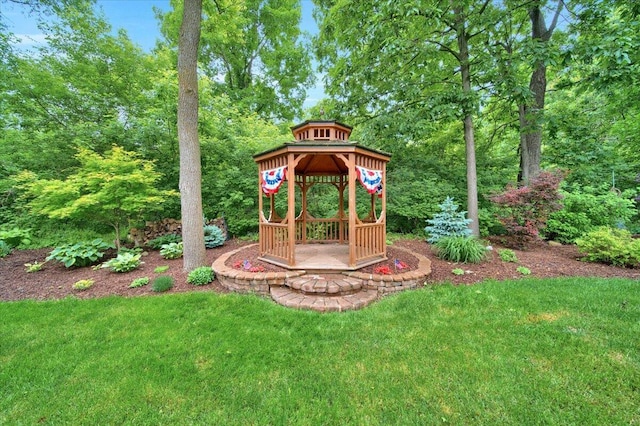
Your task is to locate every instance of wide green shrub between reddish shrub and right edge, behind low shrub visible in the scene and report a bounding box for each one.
[545,186,636,244]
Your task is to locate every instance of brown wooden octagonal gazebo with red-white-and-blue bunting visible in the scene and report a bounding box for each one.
[254,121,390,270]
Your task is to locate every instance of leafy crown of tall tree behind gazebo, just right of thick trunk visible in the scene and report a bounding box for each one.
[161,0,314,120]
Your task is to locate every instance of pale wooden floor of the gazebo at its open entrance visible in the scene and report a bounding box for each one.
[260,244,387,272]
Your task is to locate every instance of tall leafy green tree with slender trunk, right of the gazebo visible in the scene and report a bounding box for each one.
[316,0,495,235]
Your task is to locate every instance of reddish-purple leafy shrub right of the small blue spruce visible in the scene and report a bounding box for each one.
[490,171,564,248]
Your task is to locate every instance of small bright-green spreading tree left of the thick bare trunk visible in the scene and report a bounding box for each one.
[21,145,178,248]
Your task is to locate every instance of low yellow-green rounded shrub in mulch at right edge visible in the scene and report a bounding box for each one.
[576,227,640,267]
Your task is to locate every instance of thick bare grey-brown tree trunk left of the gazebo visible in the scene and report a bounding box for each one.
[178,0,206,271]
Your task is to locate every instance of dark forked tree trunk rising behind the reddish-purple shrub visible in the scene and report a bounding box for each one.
[518,0,563,182]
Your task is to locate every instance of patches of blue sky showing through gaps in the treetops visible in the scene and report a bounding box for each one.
[0,0,324,108]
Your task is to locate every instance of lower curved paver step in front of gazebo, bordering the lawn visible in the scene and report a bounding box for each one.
[271,286,378,312]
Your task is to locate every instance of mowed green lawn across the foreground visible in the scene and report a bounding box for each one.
[0,278,640,425]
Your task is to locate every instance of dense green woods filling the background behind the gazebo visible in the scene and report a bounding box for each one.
[0,0,640,244]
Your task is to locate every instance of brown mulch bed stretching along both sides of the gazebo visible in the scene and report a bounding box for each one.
[0,236,640,301]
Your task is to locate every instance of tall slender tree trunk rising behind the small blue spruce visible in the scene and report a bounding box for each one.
[454,7,480,236]
